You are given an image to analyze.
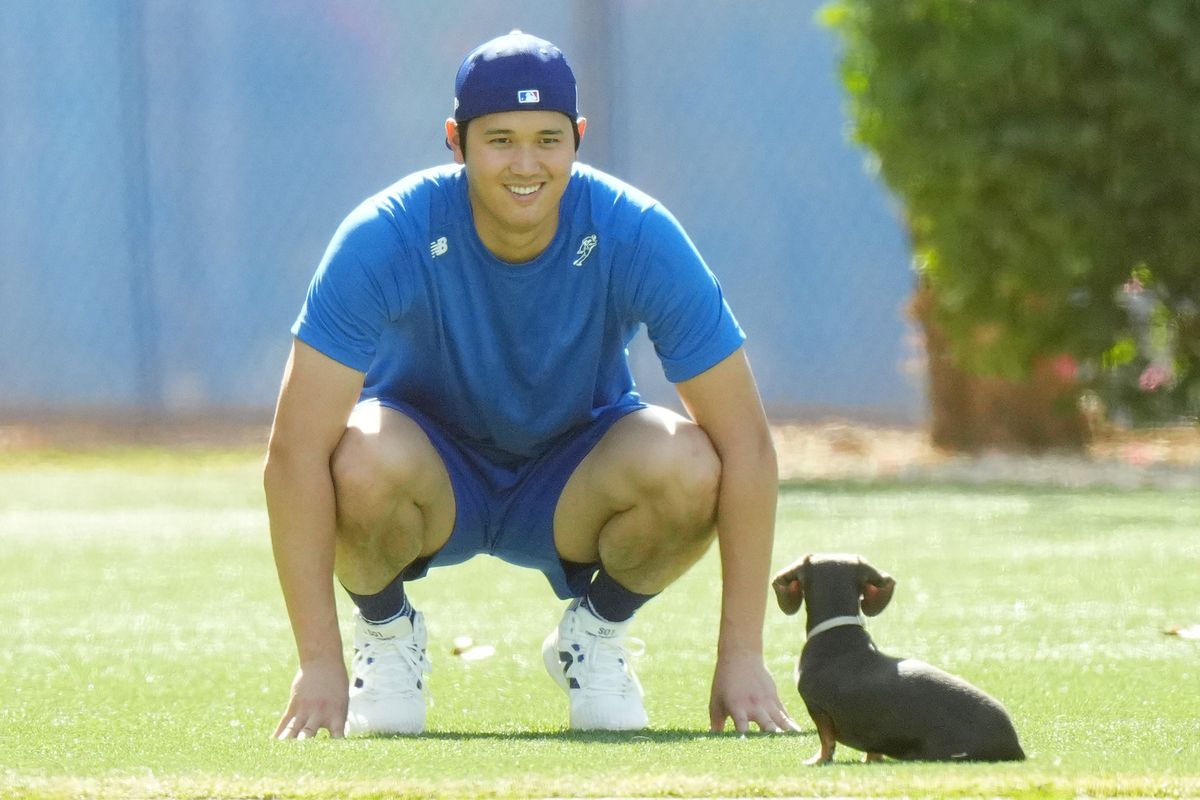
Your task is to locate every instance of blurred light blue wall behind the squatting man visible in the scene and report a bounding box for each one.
[0,0,924,422]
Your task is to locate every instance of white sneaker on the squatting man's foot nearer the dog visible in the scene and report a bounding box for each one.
[541,600,649,730]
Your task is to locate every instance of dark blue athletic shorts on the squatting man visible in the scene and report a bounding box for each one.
[366,399,646,600]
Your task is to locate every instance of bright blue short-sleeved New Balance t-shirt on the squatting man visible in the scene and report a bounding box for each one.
[292,164,745,464]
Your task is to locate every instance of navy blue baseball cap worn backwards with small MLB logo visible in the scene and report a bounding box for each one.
[454,30,580,122]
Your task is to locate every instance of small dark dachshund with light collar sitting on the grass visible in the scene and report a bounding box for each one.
[772,555,1025,764]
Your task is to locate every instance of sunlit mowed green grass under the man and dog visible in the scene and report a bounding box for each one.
[0,451,1200,798]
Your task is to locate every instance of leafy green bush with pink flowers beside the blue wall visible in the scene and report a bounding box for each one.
[822,0,1200,423]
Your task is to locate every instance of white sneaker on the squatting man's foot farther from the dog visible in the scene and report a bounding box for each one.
[346,610,430,734]
